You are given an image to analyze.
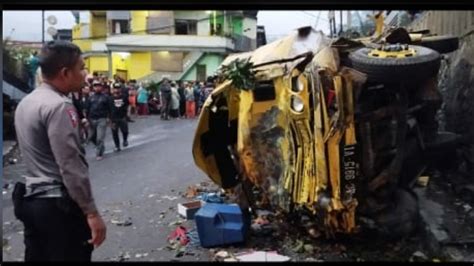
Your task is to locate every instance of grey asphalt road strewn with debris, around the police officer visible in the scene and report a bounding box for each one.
[2,116,213,261]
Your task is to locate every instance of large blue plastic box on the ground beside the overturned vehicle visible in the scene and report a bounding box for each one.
[194,203,246,247]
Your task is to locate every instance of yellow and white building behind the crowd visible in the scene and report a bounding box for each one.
[72,10,257,81]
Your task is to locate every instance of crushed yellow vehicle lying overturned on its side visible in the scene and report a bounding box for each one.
[193,27,460,237]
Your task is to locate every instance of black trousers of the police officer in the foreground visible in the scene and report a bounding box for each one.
[22,198,93,261]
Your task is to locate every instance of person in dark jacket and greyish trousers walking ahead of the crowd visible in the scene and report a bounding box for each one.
[85,80,112,161]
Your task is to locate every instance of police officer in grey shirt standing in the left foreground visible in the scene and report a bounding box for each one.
[14,41,106,261]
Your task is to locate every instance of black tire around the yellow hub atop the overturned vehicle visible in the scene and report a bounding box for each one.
[349,45,441,83]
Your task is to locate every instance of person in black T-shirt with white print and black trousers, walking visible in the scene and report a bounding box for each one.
[111,82,128,152]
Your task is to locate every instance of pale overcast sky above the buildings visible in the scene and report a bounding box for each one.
[2,11,329,41]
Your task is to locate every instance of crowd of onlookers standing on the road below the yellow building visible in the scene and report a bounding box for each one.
[67,73,214,160]
